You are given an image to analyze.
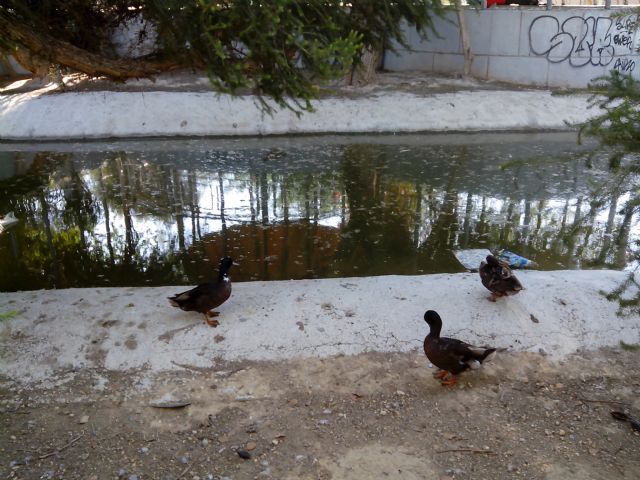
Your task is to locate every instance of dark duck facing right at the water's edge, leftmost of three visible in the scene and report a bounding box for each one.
[169,257,233,327]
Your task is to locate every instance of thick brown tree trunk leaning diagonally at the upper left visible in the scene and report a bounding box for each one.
[0,13,179,80]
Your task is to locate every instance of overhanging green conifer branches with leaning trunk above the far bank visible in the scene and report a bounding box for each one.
[0,0,443,111]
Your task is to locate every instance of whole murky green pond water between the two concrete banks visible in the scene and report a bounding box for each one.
[0,134,636,291]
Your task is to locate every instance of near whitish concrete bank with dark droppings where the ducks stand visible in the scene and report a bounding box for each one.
[0,271,640,385]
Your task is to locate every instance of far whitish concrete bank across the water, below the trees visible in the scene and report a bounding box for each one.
[0,90,599,140]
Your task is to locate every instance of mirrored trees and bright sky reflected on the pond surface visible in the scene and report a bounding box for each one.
[0,145,636,290]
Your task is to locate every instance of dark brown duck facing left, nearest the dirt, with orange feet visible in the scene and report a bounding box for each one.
[424,310,496,385]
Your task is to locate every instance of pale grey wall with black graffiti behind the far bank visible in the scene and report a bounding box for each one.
[384,7,640,87]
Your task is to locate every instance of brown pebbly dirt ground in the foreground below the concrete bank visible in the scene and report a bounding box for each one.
[0,348,640,480]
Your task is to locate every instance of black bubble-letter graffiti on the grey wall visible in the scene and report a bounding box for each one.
[529,15,638,73]
